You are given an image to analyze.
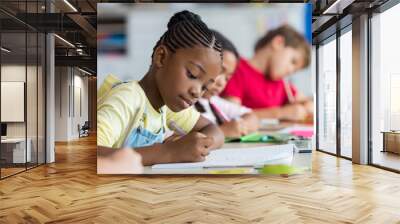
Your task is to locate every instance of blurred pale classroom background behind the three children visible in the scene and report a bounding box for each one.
[97,3,315,96]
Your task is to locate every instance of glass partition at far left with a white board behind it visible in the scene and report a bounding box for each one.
[0,1,46,179]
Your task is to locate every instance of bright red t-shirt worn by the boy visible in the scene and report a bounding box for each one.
[221,58,297,109]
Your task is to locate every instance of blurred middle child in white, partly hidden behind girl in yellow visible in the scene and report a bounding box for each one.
[195,30,258,137]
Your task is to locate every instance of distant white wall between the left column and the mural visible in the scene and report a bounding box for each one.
[55,67,88,141]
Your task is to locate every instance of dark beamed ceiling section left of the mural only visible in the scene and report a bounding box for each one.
[0,0,97,74]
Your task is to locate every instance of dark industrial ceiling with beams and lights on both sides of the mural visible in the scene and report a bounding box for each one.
[0,0,394,73]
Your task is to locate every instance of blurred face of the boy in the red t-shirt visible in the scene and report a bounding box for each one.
[266,40,304,80]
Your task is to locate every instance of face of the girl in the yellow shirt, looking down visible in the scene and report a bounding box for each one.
[156,47,221,112]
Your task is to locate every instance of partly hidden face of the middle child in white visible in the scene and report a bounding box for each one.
[203,51,238,99]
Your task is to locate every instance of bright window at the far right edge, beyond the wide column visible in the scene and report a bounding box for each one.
[370,4,400,170]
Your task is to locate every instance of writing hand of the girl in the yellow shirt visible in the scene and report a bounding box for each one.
[164,132,214,162]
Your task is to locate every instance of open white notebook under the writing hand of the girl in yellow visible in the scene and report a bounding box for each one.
[152,144,294,169]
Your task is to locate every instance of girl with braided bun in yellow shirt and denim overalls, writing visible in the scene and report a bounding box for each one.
[97,10,224,165]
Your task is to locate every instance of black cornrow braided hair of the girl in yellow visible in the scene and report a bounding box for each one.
[151,10,222,63]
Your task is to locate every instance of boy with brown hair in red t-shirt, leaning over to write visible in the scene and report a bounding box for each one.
[222,25,313,121]
